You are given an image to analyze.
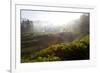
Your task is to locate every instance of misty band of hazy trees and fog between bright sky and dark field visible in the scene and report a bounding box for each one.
[21,14,89,33]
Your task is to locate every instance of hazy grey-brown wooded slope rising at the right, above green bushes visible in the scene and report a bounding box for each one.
[65,14,90,34]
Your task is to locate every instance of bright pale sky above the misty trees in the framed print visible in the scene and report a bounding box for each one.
[21,10,83,26]
